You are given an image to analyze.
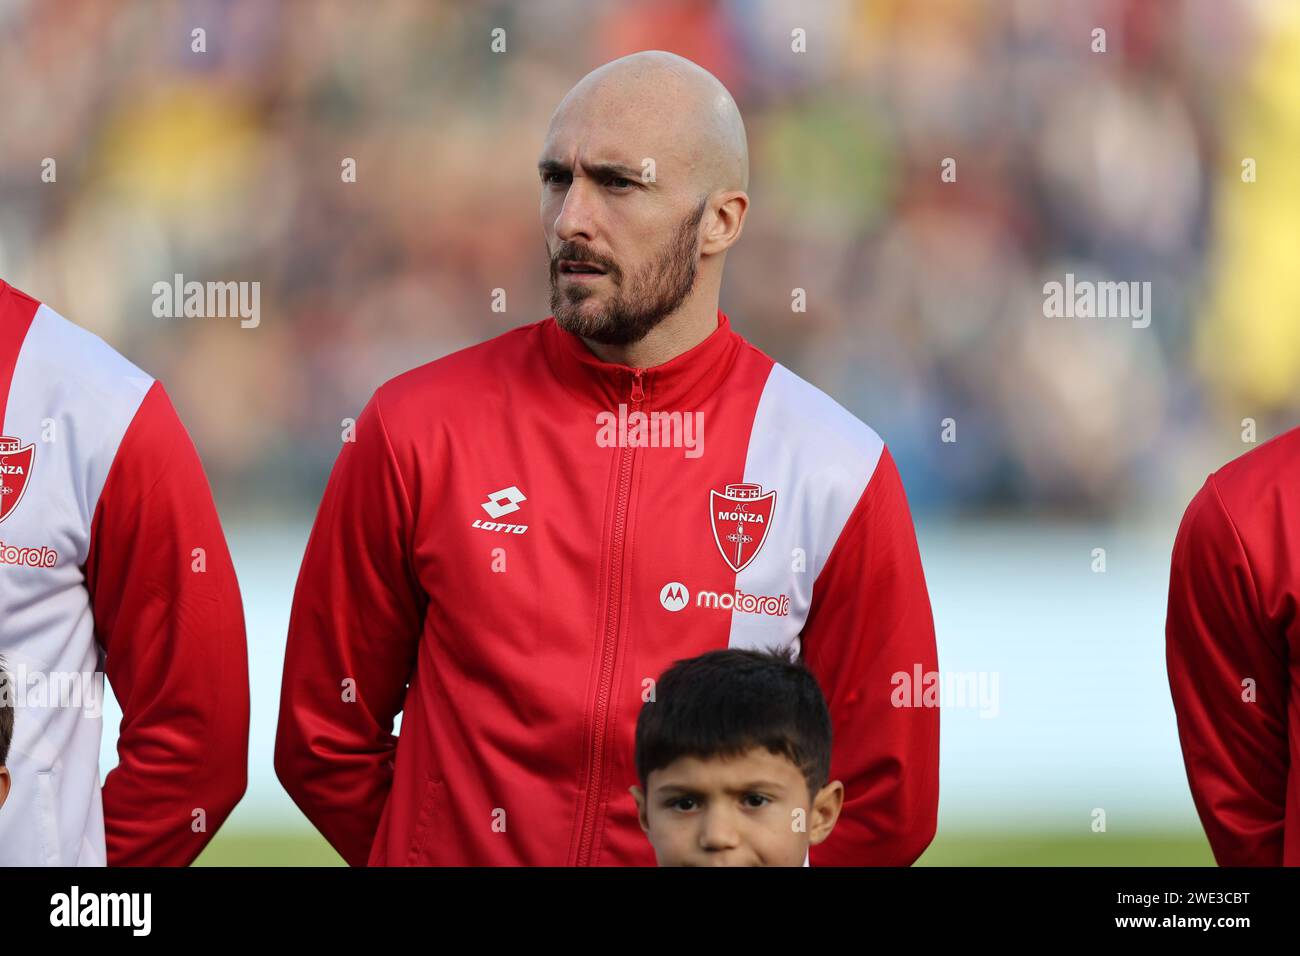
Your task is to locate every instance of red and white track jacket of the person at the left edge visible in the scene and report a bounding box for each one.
[0,281,248,866]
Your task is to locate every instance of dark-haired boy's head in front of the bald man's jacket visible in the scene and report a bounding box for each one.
[629,649,844,866]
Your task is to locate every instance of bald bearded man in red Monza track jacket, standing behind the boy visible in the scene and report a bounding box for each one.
[276,51,939,866]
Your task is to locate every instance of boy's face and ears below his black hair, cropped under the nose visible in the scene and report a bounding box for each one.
[631,747,844,866]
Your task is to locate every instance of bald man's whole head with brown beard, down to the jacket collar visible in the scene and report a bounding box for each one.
[537,51,749,364]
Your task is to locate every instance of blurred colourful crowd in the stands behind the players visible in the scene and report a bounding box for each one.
[0,0,1300,516]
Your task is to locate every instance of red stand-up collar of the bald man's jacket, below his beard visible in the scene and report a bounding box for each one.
[542,308,745,411]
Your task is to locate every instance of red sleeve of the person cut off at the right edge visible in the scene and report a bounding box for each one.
[1165,475,1287,866]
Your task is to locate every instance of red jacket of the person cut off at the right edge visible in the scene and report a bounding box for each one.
[1166,428,1300,866]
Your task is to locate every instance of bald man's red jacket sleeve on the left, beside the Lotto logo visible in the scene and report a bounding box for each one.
[276,394,426,866]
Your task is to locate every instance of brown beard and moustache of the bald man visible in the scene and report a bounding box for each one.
[551,196,709,345]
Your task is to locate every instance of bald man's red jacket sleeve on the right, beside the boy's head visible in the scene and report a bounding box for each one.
[802,449,939,866]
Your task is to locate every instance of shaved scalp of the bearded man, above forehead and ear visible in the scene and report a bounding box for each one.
[551,49,749,195]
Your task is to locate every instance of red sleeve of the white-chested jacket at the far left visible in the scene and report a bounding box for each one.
[85,382,248,866]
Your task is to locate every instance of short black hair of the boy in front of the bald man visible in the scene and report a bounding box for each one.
[636,646,831,796]
